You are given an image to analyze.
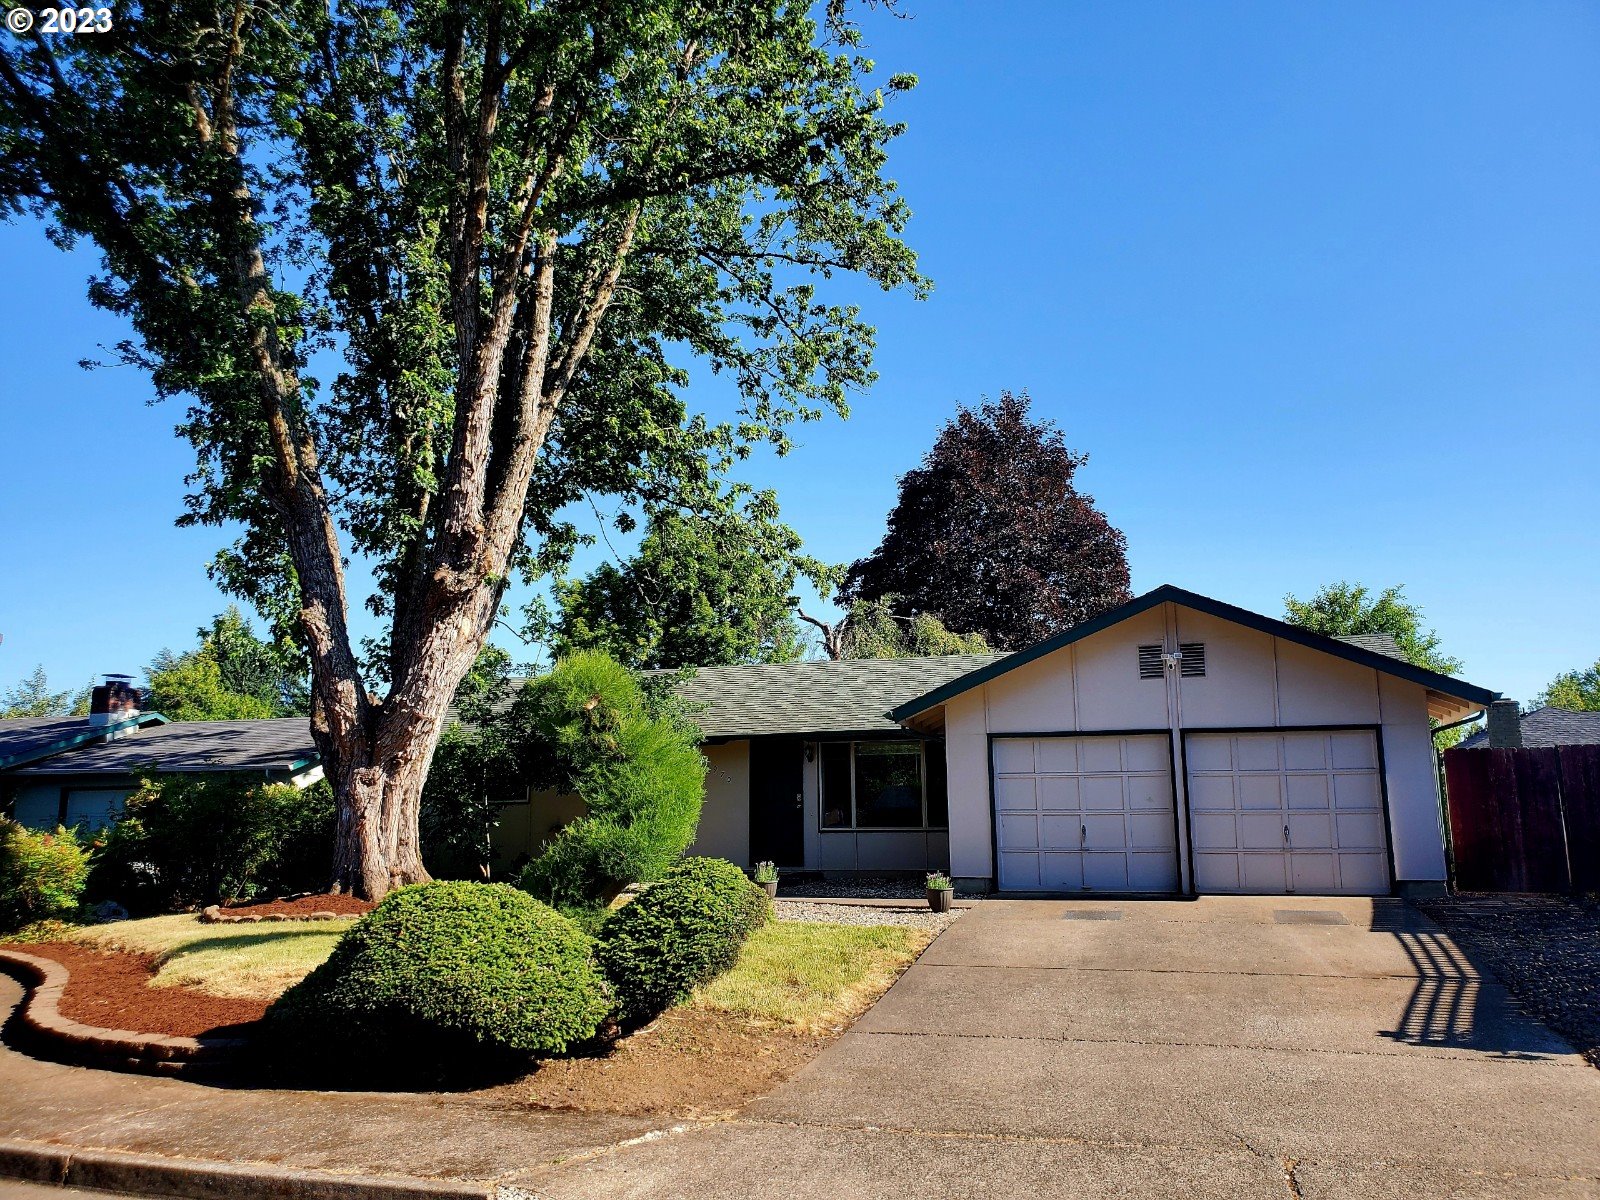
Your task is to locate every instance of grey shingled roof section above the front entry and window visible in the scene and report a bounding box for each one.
[675,654,1005,739]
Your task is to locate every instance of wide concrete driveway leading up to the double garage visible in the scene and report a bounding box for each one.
[526,898,1600,1200]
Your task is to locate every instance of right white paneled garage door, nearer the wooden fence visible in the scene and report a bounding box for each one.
[1184,730,1389,896]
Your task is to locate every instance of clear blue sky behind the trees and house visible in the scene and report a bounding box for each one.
[0,0,1600,699]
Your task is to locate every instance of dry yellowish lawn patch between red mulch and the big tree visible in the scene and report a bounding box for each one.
[74,914,355,1000]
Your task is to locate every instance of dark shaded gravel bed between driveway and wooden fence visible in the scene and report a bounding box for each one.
[1416,894,1600,1067]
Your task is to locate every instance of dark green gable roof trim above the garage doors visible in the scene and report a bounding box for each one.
[890,584,1499,722]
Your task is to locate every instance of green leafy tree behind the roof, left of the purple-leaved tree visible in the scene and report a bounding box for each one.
[530,493,814,669]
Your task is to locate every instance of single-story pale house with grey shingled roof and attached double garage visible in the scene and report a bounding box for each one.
[496,586,1498,894]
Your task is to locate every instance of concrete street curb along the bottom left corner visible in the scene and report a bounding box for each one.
[0,1141,496,1200]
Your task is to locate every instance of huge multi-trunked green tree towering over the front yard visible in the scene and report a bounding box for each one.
[0,0,922,898]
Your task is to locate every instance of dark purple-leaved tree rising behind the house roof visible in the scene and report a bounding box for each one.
[842,392,1128,650]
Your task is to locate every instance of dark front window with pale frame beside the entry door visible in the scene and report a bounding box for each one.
[821,741,949,829]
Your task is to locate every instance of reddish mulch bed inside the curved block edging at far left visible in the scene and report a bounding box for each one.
[8,942,267,1037]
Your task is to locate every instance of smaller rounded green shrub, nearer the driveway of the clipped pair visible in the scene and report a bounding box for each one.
[597,858,771,1022]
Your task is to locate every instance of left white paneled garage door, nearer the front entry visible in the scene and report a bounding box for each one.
[994,736,1178,891]
